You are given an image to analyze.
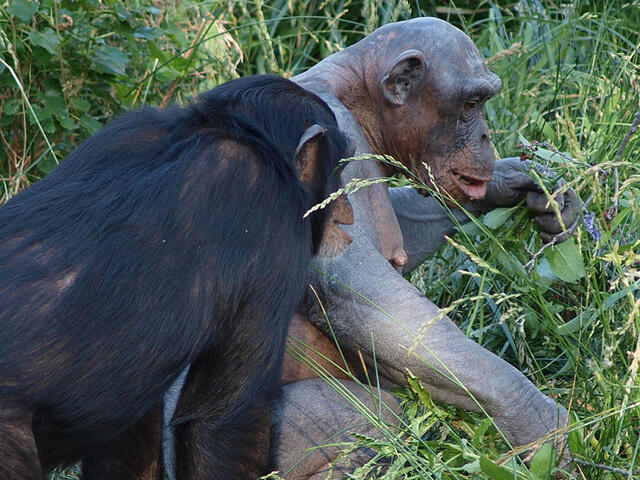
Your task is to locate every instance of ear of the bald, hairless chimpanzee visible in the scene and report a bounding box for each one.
[380,50,427,106]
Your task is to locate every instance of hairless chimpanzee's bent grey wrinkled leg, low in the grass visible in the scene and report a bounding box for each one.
[274,378,399,480]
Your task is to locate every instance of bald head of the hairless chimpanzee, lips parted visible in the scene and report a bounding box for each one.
[340,18,502,202]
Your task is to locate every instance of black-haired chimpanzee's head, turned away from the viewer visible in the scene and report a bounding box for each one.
[200,75,353,254]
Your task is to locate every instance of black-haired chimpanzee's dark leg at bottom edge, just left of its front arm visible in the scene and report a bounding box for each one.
[82,404,163,480]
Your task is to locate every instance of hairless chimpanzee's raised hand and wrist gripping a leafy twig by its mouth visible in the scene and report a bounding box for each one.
[480,157,582,242]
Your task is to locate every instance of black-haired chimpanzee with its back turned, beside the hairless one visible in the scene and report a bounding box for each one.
[0,76,347,480]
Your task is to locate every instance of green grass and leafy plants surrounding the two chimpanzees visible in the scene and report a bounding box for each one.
[0,0,640,480]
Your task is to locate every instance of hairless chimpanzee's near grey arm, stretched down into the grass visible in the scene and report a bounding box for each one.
[310,212,566,452]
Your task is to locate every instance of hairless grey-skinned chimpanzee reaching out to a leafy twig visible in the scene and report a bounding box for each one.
[165,18,579,480]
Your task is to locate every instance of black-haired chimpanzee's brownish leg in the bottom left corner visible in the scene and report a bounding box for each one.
[0,401,44,480]
